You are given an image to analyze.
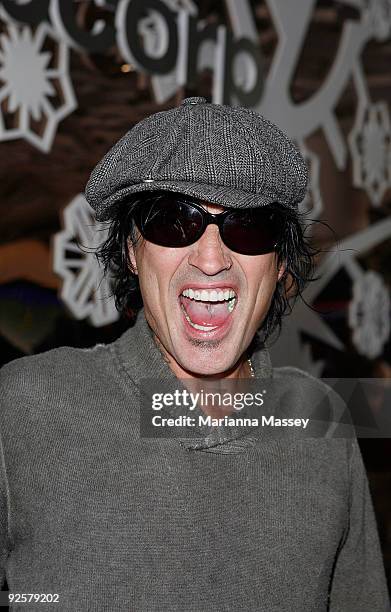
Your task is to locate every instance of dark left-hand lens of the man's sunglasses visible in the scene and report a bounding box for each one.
[138,196,203,247]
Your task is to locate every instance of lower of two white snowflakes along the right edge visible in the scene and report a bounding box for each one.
[349,271,390,359]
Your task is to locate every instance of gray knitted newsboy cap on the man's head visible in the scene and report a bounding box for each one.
[85,98,308,221]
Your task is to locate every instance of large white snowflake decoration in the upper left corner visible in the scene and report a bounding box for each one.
[0,13,76,152]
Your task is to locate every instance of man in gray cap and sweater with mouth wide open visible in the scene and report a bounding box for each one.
[1,98,388,612]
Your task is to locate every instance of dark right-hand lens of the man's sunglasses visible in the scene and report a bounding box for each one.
[223,208,282,255]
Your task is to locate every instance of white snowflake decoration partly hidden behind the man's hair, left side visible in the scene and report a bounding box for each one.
[53,194,119,327]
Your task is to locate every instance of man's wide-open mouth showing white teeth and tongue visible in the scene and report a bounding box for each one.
[179,287,237,332]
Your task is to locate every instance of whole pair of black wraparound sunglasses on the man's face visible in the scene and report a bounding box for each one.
[133,192,284,255]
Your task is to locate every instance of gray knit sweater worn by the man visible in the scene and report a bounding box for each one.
[0,313,388,612]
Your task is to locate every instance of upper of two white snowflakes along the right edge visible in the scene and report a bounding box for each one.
[349,102,391,206]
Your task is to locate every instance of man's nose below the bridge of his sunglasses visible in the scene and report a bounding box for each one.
[188,225,232,276]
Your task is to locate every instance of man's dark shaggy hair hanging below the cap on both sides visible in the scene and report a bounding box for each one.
[95,192,317,340]
